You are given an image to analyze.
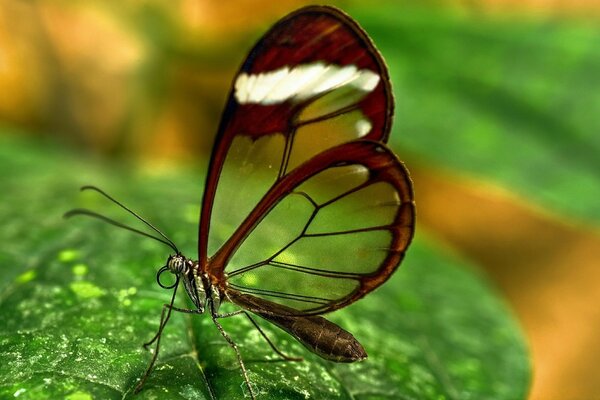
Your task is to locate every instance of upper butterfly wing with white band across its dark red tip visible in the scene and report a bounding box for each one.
[198,6,393,264]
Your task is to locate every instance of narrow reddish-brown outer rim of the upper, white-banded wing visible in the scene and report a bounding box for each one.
[198,5,394,270]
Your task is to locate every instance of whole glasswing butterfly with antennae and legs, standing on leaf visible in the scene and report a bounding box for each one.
[66,6,415,399]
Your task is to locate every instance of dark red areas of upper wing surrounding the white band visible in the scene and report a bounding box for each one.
[198,6,393,268]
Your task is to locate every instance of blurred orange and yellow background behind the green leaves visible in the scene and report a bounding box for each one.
[0,0,600,400]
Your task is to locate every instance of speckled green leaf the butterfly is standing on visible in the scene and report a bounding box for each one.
[0,136,530,400]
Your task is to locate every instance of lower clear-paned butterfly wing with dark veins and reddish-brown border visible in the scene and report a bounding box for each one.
[210,140,414,314]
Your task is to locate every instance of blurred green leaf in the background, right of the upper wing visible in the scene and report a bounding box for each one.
[348,1,600,225]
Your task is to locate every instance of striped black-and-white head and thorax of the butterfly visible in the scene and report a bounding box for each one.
[167,254,221,314]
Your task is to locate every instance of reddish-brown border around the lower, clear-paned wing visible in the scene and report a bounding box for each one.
[216,140,416,315]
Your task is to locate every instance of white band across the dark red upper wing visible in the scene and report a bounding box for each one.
[234,62,380,105]
